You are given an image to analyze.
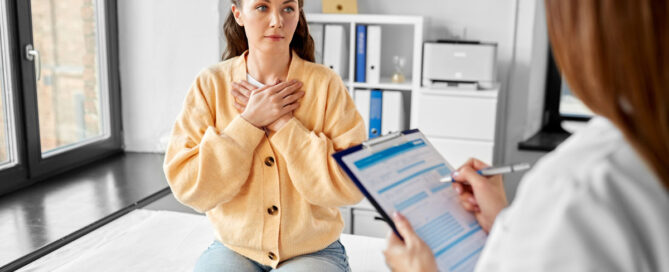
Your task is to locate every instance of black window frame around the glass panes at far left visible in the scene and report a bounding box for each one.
[0,0,123,195]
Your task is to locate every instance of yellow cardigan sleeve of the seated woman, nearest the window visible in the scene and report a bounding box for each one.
[163,71,264,212]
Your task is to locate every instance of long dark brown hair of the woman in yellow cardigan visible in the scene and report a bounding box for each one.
[222,0,316,62]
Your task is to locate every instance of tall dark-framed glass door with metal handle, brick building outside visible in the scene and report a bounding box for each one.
[17,0,120,177]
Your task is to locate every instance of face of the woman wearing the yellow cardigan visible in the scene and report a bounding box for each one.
[232,0,300,53]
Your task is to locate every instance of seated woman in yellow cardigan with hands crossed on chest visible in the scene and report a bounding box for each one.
[164,0,365,271]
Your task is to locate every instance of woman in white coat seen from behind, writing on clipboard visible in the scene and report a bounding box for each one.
[385,0,669,271]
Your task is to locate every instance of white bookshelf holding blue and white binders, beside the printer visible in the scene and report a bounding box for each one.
[306,13,424,143]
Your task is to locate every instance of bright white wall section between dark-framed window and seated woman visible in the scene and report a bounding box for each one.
[118,0,221,152]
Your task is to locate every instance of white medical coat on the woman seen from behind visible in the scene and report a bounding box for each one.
[476,117,669,271]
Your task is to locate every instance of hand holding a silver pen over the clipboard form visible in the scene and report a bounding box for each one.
[450,159,528,232]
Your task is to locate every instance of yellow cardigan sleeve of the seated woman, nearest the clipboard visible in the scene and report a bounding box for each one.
[270,74,365,207]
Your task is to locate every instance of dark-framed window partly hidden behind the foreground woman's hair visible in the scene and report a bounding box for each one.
[518,48,593,151]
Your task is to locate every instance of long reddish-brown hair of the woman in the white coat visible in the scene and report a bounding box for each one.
[546,0,669,190]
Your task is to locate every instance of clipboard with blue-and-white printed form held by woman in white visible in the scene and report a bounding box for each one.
[332,129,487,271]
